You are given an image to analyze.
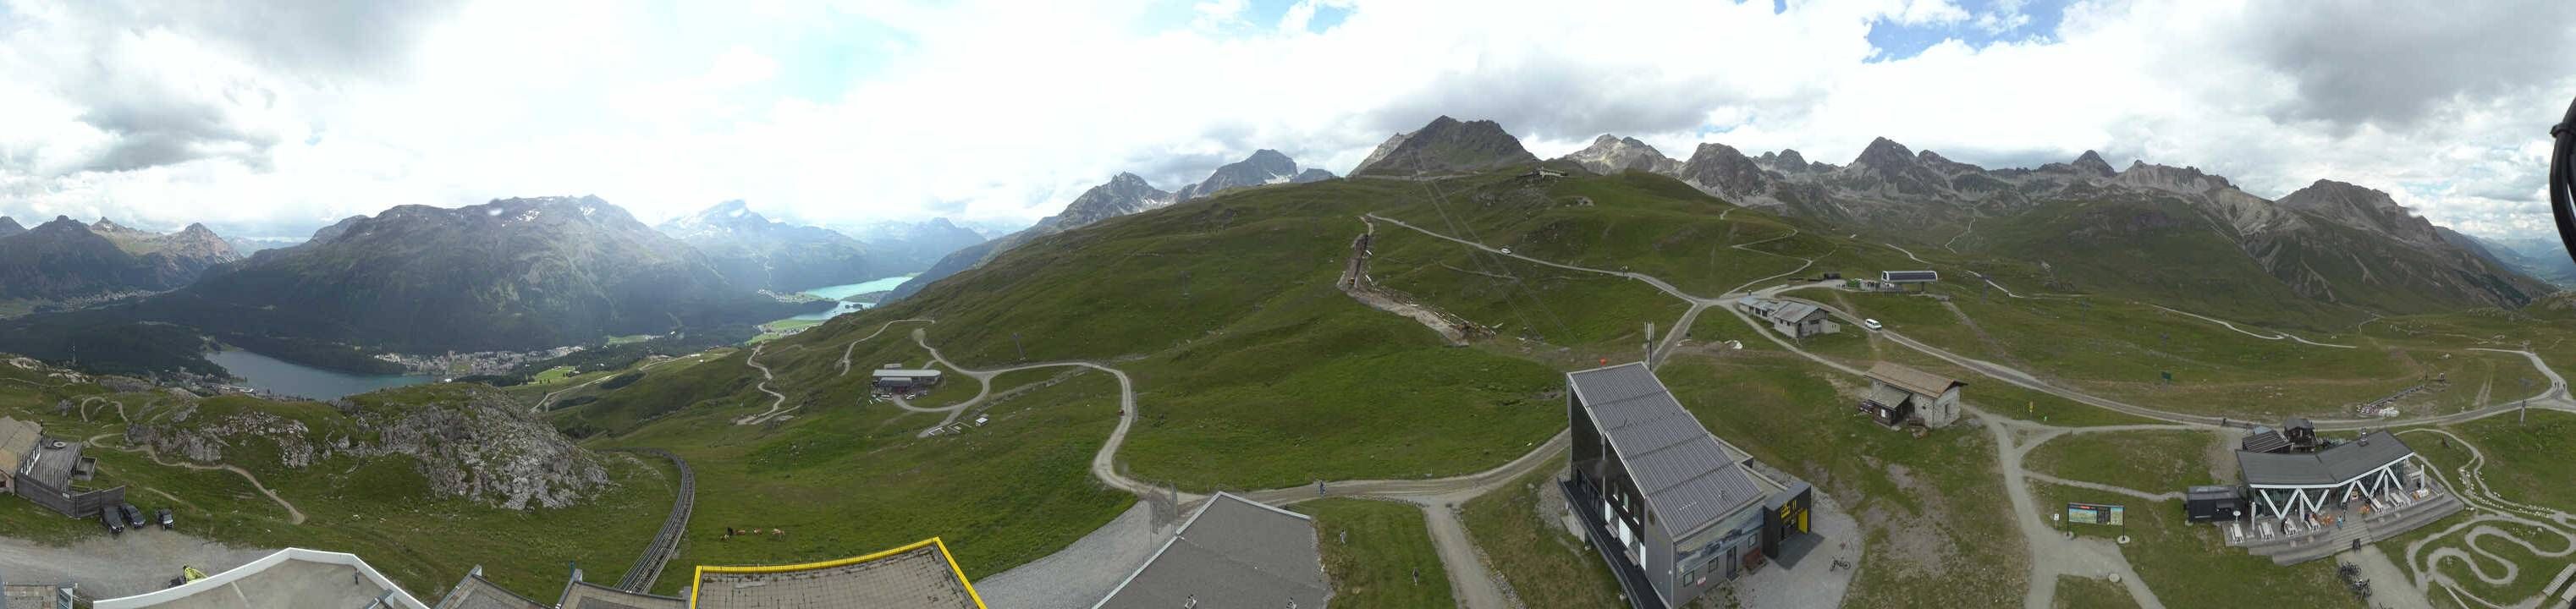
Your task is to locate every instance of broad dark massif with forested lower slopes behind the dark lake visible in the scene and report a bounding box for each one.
[0,198,814,370]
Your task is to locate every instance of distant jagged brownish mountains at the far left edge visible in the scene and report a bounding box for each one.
[0,216,242,300]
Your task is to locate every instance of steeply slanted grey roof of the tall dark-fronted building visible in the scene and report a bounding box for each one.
[1566,362,1762,540]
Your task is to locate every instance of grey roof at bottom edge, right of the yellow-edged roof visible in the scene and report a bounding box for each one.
[1093,493,1332,609]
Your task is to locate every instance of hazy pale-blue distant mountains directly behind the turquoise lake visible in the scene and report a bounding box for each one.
[654,200,896,293]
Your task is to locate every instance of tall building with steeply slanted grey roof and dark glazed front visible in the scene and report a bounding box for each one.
[1561,362,1814,609]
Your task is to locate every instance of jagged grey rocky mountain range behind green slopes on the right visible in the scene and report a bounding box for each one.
[1545,136,2553,314]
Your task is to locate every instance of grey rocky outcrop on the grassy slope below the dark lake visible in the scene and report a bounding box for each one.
[126,386,610,509]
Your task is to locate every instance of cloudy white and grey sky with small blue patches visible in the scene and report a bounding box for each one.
[0,0,2576,236]
